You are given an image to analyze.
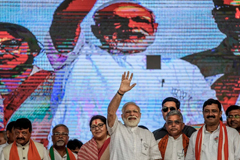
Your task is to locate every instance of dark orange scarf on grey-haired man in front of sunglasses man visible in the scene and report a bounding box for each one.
[158,133,189,160]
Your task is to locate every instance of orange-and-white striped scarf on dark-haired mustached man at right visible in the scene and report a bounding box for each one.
[195,121,228,160]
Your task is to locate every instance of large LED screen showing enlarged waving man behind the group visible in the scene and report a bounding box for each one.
[0,0,237,145]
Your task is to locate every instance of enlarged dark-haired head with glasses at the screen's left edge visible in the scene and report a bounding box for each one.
[0,23,40,78]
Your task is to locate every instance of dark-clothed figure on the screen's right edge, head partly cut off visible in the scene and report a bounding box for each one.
[182,0,240,111]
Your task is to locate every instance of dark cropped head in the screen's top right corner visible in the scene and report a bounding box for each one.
[212,0,240,39]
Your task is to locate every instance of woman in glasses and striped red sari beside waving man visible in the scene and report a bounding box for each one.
[78,115,110,160]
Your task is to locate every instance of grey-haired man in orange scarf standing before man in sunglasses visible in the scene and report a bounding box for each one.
[158,110,189,160]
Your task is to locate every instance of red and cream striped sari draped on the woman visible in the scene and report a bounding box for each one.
[78,137,110,160]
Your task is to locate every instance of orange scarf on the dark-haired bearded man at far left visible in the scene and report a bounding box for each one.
[9,139,41,160]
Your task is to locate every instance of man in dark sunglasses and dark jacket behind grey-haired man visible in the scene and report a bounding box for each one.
[153,97,196,141]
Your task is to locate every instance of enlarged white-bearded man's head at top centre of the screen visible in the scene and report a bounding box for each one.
[92,3,158,54]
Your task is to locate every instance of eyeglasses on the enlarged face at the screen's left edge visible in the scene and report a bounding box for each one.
[0,39,22,50]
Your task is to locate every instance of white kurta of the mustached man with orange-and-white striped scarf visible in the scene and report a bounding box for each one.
[186,126,240,160]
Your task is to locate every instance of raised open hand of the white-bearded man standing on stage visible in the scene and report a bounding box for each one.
[119,71,136,94]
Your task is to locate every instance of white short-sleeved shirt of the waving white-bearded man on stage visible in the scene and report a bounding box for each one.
[107,117,162,160]
